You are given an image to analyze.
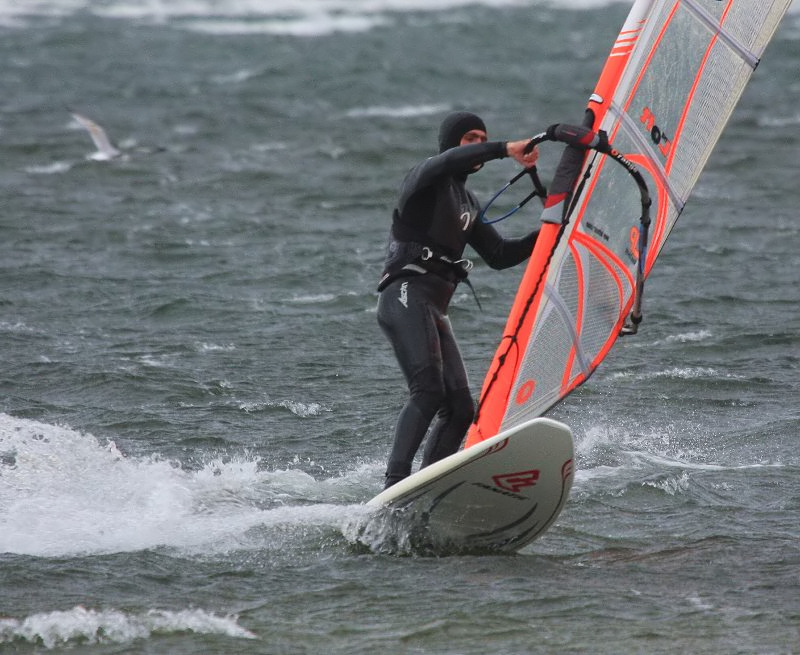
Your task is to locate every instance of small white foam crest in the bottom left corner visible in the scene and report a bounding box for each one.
[0,605,257,648]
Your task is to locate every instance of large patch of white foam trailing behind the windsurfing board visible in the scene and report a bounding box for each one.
[0,414,372,557]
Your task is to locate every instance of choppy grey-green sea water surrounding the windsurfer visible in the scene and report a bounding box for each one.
[0,0,800,653]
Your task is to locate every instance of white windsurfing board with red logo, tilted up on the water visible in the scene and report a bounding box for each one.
[358,418,574,555]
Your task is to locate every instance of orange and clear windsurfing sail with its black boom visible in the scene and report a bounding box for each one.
[466,0,791,447]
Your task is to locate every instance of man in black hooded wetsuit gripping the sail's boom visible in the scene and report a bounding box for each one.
[378,112,538,487]
